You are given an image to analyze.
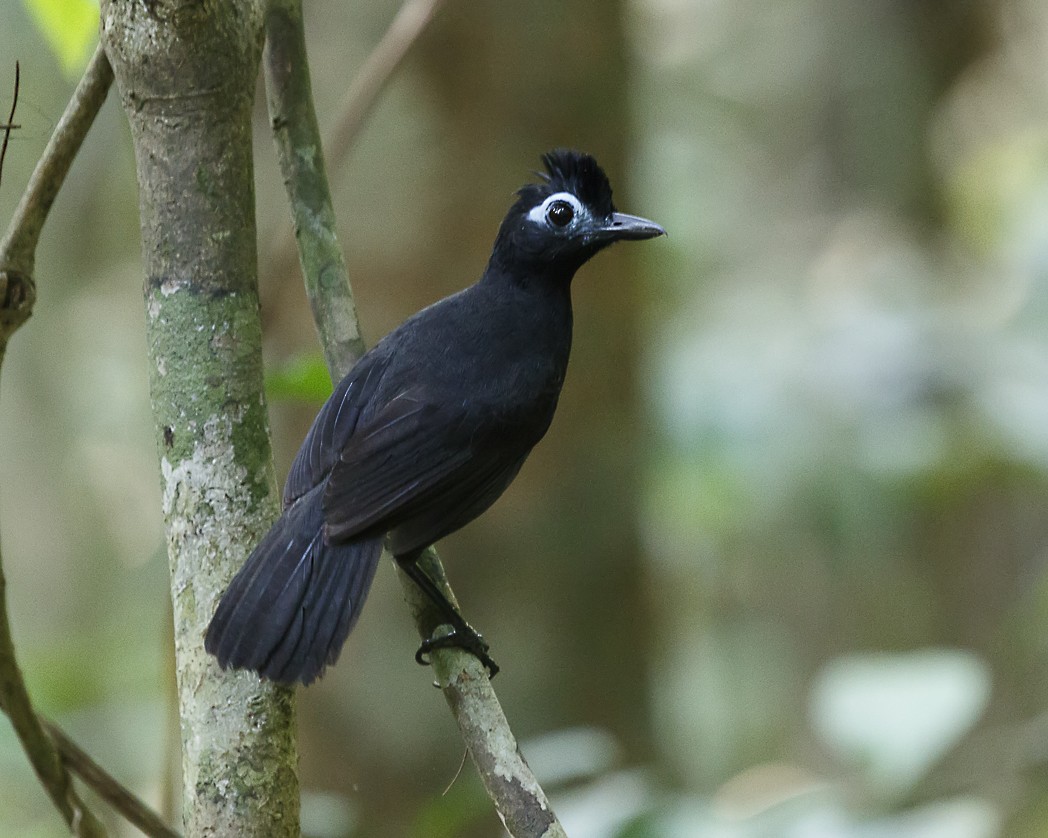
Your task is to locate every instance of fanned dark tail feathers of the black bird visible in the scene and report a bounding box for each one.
[204,486,383,684]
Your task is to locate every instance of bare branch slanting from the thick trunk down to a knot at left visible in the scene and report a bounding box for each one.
[0,45,113,277]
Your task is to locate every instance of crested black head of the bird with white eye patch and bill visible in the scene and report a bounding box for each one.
[492,149,665,280]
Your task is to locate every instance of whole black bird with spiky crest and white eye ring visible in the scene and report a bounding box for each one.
[205,150,664,684]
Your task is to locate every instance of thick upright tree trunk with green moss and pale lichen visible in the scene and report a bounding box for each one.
[103,0,299,836]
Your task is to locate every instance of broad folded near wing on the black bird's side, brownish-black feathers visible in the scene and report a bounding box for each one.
[324,391,530,547]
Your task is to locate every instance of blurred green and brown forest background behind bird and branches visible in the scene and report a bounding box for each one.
[0,0,1048,838]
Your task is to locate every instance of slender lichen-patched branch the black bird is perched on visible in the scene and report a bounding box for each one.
[264,0,565,838]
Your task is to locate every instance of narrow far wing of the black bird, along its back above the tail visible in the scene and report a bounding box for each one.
[284,350,389,508]
